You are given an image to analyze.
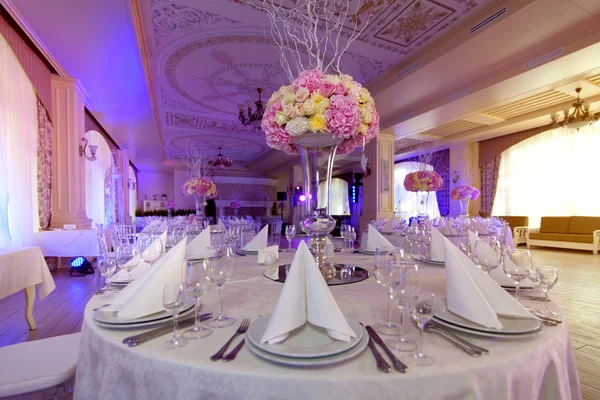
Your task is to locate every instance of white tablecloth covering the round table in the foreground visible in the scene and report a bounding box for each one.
[75,253,581,400]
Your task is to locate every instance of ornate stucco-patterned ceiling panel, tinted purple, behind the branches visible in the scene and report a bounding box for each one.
[139,0,494,164]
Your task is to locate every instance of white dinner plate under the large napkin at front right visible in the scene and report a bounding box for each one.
[433,301,541,336]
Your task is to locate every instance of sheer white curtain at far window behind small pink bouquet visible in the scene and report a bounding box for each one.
[394,161,440,219]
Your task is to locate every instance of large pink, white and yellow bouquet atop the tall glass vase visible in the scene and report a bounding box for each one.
[262,69,379,154]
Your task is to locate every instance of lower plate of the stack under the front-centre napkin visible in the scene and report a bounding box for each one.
[246,325,369,367]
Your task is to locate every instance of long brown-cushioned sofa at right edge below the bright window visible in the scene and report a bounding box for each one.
[527,217,600,254]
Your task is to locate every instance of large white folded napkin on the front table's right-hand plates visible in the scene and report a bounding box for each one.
[444,238,533,329]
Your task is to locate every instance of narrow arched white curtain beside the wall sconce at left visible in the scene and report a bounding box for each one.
[85,131,111,224]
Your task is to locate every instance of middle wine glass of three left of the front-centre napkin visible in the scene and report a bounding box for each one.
[184,261,212,339]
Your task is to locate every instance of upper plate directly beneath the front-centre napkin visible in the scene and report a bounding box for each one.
[246,315,363,358]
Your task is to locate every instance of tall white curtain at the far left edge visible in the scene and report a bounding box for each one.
[0,35,39,248]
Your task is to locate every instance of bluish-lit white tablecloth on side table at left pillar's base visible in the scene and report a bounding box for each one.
[33,229,100,257]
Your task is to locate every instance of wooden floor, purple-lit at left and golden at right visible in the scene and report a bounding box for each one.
[0,248,600,400]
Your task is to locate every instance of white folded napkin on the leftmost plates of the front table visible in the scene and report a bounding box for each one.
[103,240,186,320]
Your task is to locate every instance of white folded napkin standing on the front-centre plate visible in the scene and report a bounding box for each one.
[261,242,356,344]
